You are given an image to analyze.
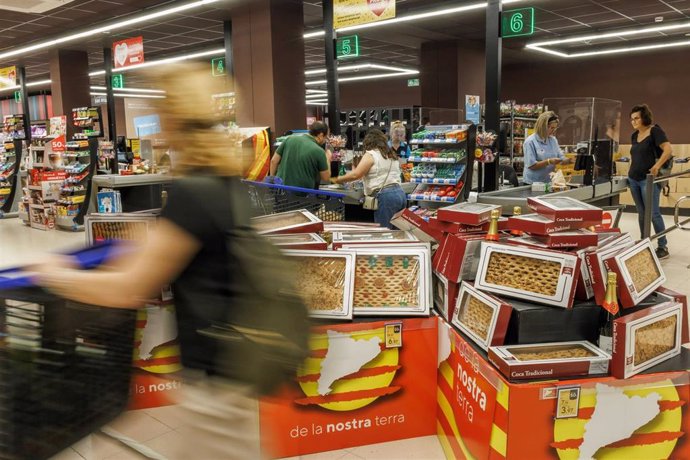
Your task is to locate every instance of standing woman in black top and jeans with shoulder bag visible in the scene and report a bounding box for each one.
[628,104,673,259]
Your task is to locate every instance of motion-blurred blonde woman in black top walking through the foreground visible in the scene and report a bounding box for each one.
[30,65,260,459]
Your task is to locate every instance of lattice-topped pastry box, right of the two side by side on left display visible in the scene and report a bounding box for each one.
[350,247,433,316]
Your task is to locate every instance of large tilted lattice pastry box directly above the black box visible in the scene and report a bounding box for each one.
[475,242,580,308]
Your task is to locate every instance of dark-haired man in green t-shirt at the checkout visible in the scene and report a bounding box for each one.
[271,121,331,189]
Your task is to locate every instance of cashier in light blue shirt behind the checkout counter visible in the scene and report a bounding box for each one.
[522,111,571,185]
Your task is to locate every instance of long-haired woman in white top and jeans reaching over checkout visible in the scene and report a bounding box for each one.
[332,129,407,228]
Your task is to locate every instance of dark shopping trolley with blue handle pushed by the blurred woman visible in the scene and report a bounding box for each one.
[0,245,136,460]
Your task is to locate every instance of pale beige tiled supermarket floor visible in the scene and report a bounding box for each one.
[0,214,690,460]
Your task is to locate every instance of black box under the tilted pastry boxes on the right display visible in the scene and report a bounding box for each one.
[505,299,601,344]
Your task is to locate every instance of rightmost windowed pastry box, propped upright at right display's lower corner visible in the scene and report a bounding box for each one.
[611,302,683,379]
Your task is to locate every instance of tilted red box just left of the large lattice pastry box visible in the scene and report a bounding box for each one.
[432,233,485,283]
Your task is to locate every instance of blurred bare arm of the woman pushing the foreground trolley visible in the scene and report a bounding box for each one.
[32,219,201,308]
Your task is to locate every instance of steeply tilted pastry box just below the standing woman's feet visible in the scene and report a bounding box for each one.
[604,238,666,308]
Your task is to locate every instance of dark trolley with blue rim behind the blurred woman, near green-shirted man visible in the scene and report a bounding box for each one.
[243,181,345,222]
